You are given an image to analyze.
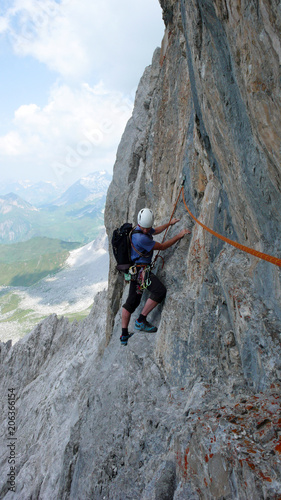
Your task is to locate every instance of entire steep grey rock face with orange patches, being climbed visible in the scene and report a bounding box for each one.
[0,0,281,500]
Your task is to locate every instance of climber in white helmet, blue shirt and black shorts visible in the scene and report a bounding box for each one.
[120,208,190,345]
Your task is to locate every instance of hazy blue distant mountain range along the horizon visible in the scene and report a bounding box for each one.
[0,172,111,244]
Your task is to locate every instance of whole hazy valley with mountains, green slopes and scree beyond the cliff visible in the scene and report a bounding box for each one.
[0,172,111,342]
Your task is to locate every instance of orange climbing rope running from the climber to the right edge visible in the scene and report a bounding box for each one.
[158,176,281,267]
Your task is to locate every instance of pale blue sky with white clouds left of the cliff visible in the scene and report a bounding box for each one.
[0,0,164,185]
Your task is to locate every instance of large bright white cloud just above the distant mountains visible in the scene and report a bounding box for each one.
[0,83,133,180]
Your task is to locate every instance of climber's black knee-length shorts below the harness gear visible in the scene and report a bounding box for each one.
[123,273,167,314]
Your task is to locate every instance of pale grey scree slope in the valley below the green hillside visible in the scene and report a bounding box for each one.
[0,229,109,343]
